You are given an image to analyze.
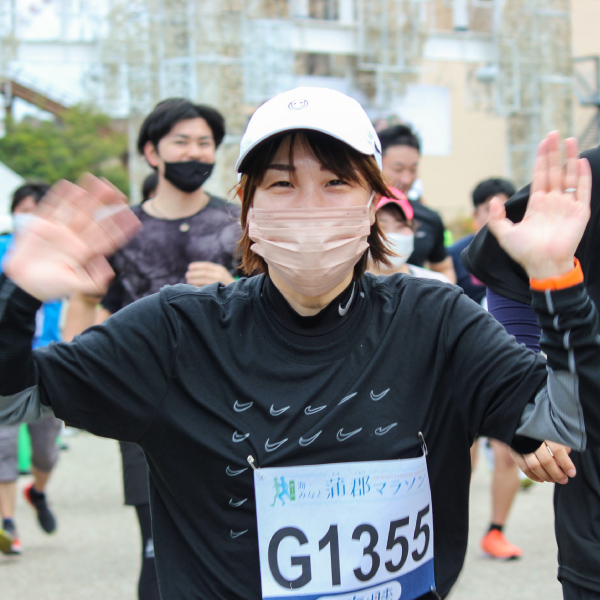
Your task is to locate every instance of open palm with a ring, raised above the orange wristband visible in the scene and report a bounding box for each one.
[488,131,592,279]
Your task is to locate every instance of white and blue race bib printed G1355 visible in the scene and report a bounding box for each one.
[254,456,435,600]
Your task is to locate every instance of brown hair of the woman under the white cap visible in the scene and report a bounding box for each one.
[238,129,394,278]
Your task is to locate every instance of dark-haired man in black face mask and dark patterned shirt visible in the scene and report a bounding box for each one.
[63,98,241,600]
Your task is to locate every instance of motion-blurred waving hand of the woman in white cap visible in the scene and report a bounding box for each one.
[3,175,140,300]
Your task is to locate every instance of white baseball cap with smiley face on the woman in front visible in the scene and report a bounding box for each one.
[235,87,381,172]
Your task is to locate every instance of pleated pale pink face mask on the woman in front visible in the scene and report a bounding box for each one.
[248,192,375,297]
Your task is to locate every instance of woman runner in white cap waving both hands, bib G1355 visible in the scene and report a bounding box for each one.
[0,88,600,600]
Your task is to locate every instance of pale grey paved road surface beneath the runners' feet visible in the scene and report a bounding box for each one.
[0,433,562,600]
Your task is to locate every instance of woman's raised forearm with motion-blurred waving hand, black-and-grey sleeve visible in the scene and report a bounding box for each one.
[0,175,139,423]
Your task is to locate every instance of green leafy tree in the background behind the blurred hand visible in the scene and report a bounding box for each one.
[0,106,129,194]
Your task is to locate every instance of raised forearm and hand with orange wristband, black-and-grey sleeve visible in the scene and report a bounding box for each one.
[489,133,600,450]
